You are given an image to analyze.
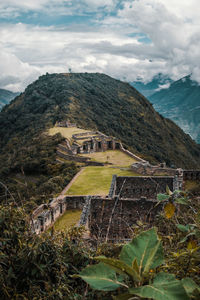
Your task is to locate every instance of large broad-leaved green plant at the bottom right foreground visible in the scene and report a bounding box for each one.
[75,228,200,300]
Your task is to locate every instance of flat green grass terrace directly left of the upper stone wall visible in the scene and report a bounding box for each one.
[66,167,137,196]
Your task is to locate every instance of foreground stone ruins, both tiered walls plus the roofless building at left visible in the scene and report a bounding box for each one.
[31,175,184,242]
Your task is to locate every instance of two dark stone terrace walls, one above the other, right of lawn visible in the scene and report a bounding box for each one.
[88,175,180,242]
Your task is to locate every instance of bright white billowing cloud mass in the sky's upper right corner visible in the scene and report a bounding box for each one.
[114,0,200,81]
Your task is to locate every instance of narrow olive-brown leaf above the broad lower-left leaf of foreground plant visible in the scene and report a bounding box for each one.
[95,256,140,281]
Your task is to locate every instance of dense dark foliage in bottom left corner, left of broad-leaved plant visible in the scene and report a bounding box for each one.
[0,205,90,300]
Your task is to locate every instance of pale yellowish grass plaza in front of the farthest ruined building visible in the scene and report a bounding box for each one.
[79,150,136,167]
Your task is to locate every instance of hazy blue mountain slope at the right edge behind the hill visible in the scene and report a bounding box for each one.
[149,75,200,144]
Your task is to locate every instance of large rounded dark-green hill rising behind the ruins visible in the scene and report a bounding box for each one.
[0,73,200,169]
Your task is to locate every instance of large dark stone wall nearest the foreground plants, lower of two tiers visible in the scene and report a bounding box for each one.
[89,197,162,242]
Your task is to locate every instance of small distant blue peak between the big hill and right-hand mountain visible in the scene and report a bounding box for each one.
[130,73,173,98]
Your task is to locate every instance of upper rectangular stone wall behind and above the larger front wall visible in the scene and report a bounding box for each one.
[115,176,174,199]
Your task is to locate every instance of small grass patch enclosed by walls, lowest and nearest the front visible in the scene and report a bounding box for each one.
[49,209,81,231]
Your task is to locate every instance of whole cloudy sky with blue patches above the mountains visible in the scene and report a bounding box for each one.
[0,0,200,92]
